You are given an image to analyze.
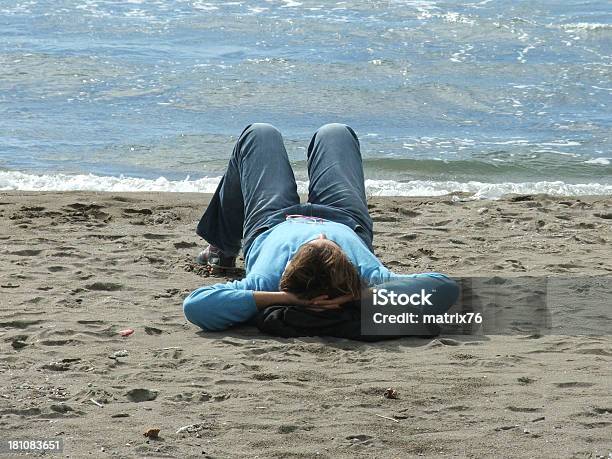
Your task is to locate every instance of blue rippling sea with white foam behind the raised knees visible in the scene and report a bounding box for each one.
[0,0,612,197]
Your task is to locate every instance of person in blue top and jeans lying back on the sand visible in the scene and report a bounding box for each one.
[183,123,459,331]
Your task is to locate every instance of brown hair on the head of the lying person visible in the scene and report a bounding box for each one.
[280,244,361,300]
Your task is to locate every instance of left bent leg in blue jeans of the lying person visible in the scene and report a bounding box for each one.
[196,123,300,256]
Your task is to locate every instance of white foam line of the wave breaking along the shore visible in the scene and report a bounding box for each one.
[0,171,612,199]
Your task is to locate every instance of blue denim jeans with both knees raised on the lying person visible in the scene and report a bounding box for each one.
[196,123,373,255]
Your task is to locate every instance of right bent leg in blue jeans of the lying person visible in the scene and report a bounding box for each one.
[308,123,372,242]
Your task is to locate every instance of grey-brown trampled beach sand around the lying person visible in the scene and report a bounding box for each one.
[0,192,612,458]
